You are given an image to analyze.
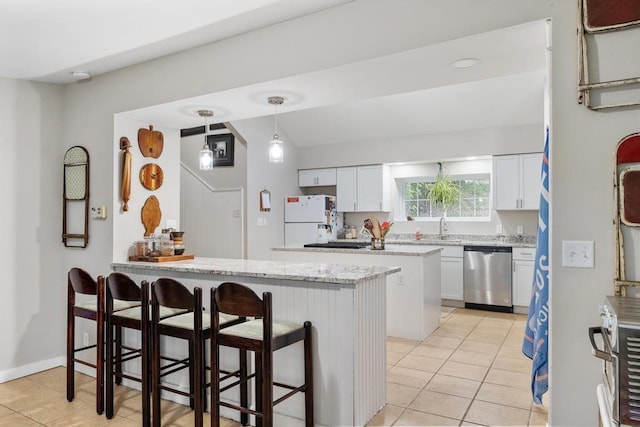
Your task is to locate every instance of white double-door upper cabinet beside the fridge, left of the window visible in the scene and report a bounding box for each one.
[336,165,390,212]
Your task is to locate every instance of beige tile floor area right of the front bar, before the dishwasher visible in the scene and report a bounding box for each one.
[367,308,547,426]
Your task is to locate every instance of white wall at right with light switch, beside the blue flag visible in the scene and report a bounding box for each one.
[550,2,640,425]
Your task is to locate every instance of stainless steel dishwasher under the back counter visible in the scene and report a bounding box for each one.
[462,246,513,313]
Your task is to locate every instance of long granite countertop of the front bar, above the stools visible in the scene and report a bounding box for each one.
[111,257,400,285]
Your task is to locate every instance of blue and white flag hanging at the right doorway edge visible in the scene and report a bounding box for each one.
[522,128,549,404]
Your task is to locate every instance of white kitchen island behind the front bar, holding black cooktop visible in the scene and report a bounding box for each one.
[272,244,442,341]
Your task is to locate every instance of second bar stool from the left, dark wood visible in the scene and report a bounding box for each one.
[105,272,186,426]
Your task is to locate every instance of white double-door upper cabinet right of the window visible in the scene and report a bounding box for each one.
[493,153,542,210]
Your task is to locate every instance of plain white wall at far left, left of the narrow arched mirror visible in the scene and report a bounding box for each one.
[0,78,65,382]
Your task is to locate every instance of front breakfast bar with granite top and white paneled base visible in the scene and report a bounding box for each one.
[112,257,399,426]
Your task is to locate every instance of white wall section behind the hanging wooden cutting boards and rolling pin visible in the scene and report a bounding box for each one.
[112,114,180,261]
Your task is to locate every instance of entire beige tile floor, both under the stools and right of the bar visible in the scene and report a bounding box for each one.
[0,309,547,427]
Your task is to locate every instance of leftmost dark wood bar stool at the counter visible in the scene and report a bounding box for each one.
[67,267,104,414]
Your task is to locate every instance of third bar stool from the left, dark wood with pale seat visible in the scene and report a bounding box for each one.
[151,278,242,427]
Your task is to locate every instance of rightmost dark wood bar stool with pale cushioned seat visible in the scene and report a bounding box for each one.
[211,282,313,427]
